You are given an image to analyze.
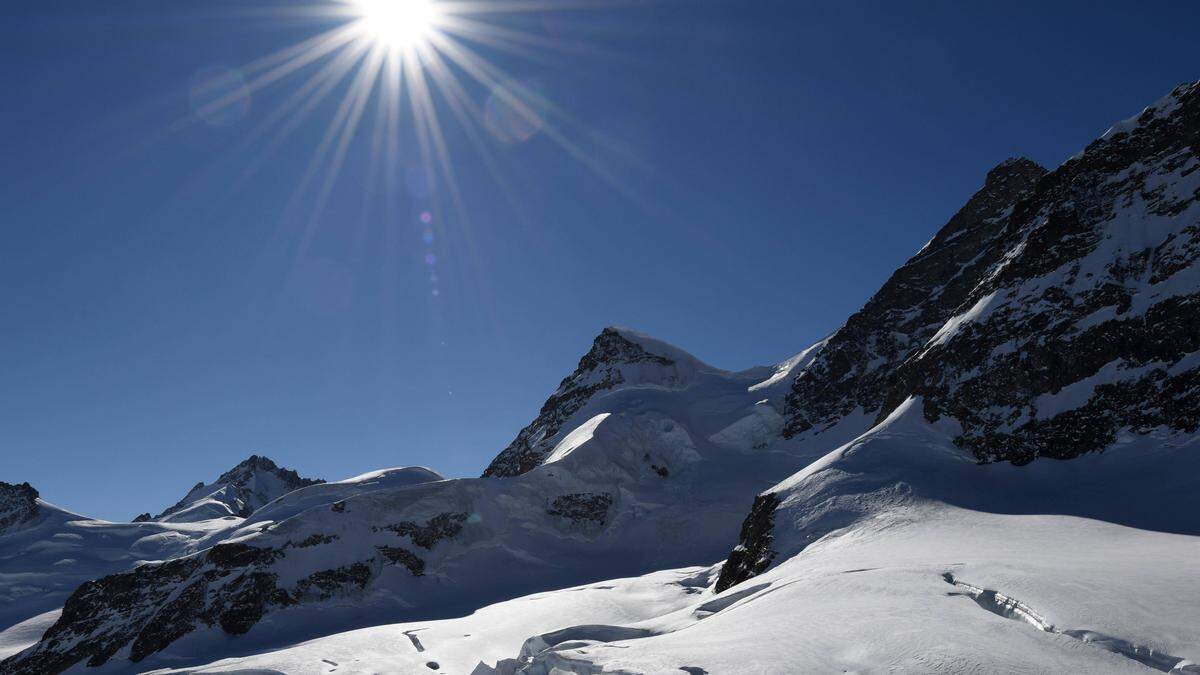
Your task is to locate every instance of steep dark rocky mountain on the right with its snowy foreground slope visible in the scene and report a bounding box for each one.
[476,78,1200,675]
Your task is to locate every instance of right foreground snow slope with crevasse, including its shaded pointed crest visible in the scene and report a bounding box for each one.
[487,400,1200,675]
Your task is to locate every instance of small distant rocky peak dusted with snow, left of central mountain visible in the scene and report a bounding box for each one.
[154,455,324,522]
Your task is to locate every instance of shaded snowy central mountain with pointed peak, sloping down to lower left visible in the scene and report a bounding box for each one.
[0,329,835,673]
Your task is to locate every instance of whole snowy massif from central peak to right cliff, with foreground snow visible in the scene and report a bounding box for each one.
[0,83,1200,675]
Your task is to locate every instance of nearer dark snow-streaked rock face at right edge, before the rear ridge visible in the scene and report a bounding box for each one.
[886,84,1200,464]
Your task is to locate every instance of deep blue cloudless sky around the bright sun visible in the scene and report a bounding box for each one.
[0,0,1200,519]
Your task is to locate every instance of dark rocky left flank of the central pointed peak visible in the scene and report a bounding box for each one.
[484,328,674,477]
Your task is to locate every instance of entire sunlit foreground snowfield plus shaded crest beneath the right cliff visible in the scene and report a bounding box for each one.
[131,401,1200,675]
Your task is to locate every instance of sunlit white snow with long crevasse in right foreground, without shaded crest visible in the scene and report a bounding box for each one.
[501,507,1200,675]
